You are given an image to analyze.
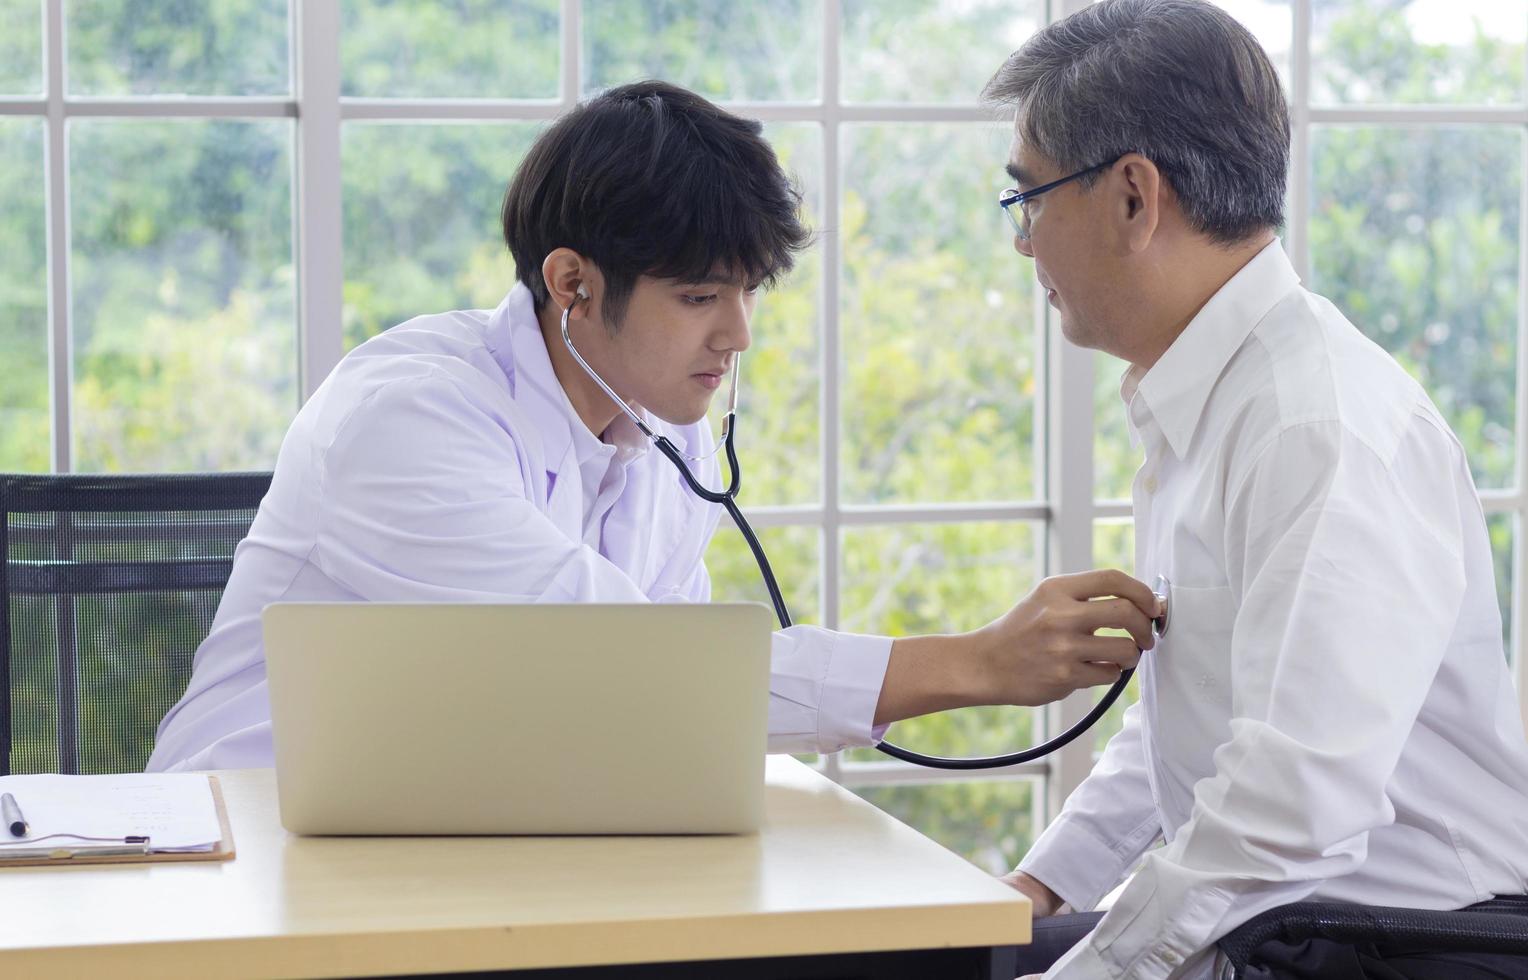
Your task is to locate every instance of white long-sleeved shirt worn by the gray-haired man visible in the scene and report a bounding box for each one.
[1019,242,1528,980]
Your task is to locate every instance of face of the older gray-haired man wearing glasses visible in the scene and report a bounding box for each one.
[1008,139,1128,353]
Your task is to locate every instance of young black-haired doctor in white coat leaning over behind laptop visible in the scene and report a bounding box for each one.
[148,83,1157,769]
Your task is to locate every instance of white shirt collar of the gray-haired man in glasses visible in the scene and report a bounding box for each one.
[1120,239,1300,459]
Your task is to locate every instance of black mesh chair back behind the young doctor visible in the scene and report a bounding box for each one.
[0,472,270,775]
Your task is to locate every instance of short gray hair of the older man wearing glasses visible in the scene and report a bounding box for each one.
[983,0,1290,245]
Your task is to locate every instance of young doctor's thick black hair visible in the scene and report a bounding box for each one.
[501,81,811,329]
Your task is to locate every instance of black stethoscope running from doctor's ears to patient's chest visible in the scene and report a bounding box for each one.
[562,284,1172,769]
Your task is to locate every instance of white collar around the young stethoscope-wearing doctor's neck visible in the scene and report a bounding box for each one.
[487,283,660,468]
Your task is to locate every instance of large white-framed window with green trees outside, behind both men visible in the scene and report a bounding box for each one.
[0,0,1528,870]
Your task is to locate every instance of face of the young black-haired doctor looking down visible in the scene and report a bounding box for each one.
[581,275,758,425]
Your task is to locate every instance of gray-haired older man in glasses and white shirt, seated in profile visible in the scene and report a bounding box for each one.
[987,0,1528,980]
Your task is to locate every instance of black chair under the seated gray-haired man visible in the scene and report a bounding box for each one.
[1218,897,1528,980]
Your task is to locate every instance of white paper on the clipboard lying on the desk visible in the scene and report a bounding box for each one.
[0,772,223,859]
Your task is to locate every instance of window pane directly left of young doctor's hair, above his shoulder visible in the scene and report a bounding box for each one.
[341,122,541,349]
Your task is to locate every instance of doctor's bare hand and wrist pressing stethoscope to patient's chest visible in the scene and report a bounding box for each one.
[876,570,1158,725]
